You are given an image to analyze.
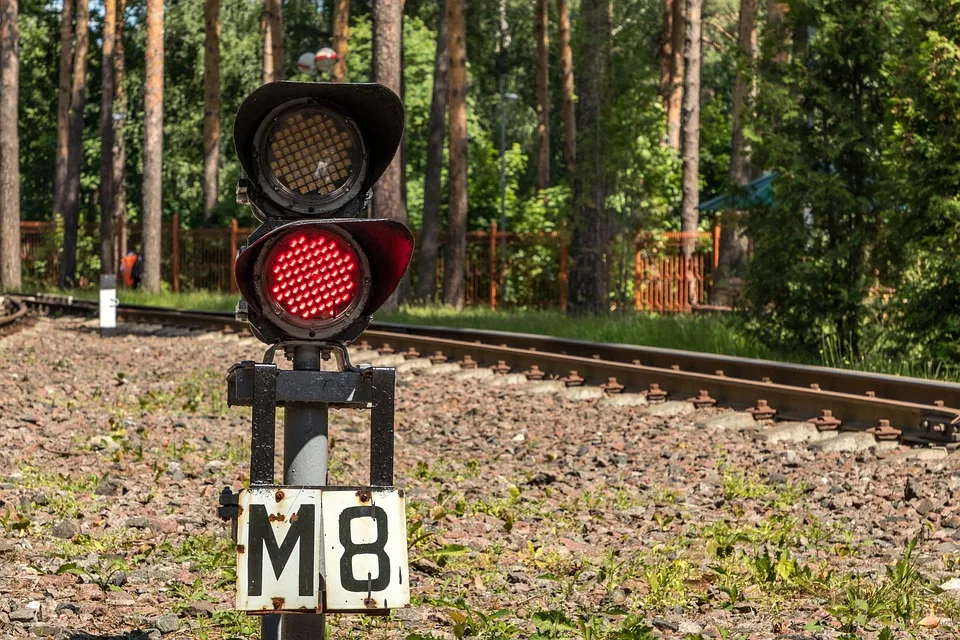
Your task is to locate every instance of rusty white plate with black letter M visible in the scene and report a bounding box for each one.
[237,487,321,611]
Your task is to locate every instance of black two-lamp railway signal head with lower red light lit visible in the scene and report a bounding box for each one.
[234,82,413,343]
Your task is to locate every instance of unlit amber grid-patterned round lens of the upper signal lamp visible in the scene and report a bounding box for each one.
[267,108,357,197]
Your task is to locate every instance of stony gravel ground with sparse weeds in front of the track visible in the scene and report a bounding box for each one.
[0,319,960,640]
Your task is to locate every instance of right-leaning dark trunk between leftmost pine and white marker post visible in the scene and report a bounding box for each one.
[57,0,90,288]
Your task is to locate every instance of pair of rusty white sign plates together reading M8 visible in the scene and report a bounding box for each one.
[236,487,410,613]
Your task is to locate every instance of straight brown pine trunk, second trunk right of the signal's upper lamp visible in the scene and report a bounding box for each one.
[443,0,467,309]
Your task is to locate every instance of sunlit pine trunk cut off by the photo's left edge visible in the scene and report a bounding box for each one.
[0,0,21,291]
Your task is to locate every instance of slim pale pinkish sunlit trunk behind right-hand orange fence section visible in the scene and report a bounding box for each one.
[680,0,703,262]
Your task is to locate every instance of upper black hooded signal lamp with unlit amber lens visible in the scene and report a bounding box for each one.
[233,82,404,220]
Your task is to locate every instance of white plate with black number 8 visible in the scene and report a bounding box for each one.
[321,489,410,611]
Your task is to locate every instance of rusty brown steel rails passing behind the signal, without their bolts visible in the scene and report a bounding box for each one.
[13,296,960,444]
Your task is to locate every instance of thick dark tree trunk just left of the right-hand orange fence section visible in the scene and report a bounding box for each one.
[568,0,610,313]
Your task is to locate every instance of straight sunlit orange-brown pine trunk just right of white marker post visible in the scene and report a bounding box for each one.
[142,0,163,292]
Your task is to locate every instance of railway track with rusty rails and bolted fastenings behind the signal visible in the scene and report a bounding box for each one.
[9,295,960,448]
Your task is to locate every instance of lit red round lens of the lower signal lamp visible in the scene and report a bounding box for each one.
[263,229,362,322]
